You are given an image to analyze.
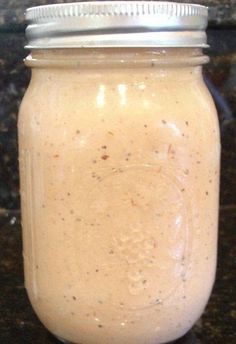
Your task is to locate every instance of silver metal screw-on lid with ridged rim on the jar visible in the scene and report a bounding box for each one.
[26,1,208,49]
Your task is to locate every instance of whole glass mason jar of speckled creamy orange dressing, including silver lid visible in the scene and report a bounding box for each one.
[19,2,220,344]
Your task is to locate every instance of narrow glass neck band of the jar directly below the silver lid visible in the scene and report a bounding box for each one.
[25,48,208,68]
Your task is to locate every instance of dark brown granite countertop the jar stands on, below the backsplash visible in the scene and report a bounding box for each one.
[0,206,236,344]
